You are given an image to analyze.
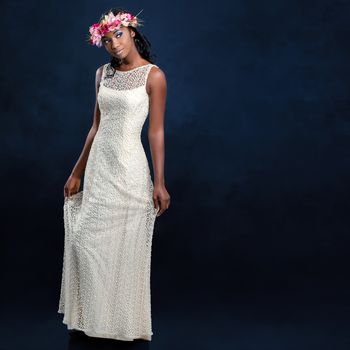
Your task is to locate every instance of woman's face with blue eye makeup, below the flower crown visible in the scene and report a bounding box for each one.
[102,26,135,60]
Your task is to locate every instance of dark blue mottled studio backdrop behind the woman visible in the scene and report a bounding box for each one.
[0,0,350,350]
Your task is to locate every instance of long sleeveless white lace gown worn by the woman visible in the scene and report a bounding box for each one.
[58,63,157,341]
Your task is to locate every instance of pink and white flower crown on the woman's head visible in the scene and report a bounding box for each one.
[88,10,143,47]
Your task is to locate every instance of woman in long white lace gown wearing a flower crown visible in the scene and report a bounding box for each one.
[58,9,170,341]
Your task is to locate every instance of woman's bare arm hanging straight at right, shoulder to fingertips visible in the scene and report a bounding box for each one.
[147,67,170,216]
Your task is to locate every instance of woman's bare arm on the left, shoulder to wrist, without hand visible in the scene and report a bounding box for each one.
[72,66,103,178]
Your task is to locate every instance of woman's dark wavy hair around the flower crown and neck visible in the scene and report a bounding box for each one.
[99,7,154,68]
